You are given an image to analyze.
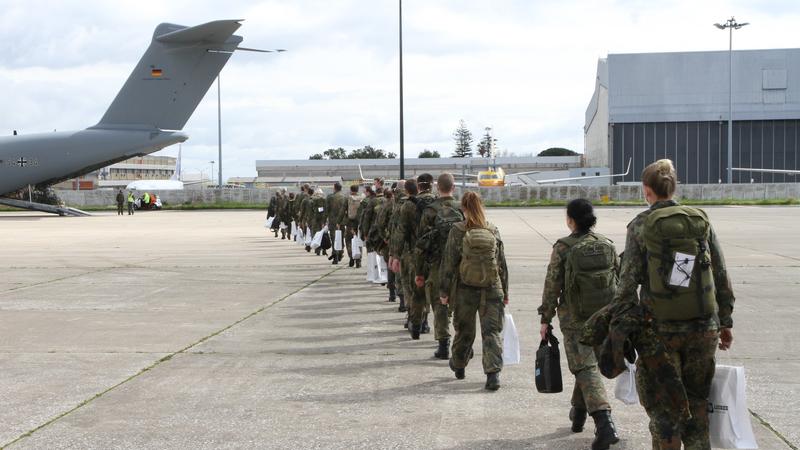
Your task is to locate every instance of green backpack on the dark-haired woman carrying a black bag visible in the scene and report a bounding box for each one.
[558,233,617,320]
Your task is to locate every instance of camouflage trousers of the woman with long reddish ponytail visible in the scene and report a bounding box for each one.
[451,286,505,374]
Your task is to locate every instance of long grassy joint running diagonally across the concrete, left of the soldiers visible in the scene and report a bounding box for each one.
[0,267,343,450]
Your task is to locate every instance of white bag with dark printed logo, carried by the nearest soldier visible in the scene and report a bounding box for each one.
[708,366,758,449]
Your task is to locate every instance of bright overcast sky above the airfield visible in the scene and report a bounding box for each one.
[0,0,800,178]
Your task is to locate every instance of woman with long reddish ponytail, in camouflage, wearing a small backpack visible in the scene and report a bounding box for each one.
[439,192,508,391]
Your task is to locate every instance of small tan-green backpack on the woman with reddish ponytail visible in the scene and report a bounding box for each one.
[456,224,500,288]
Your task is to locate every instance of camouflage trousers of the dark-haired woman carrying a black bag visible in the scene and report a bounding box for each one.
[561,328,611,414]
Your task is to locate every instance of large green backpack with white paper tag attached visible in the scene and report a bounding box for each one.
[644,205,717,321]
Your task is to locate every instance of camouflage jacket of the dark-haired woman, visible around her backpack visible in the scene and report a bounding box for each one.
[538,233,619,330]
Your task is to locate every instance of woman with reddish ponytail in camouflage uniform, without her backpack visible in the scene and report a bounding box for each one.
[439,192,508,390]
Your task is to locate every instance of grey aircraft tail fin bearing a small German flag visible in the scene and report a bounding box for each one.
[96,20,242,130]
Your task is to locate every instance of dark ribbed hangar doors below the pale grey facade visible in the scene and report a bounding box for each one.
[609,120,800,184]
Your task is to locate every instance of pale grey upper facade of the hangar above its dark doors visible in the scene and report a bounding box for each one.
[586,49,800,124]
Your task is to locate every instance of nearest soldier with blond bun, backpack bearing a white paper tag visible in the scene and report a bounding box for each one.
[614,159,734,449]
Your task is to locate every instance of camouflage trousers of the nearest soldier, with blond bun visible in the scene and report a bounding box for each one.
[636,330,719,450]
